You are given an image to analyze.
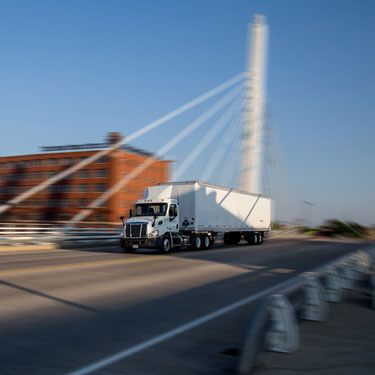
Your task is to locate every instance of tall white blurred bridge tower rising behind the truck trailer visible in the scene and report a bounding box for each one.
[239,14,268,194]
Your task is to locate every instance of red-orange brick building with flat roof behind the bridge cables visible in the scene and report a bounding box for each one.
[0,133,170,222]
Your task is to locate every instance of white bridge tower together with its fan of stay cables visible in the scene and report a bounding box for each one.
[0,15,267,227]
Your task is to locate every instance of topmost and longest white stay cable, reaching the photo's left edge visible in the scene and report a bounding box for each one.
[0,73,247,214]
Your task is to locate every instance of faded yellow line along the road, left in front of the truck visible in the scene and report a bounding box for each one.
[0,256,166,277]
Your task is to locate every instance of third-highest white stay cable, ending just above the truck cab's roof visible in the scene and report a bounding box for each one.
[172,93,245,181]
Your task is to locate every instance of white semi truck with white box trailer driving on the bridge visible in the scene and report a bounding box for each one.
[120,181,271,253]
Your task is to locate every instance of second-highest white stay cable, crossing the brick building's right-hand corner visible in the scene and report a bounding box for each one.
[67,84,243,226]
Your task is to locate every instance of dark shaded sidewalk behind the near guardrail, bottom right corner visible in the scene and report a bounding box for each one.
[253,291,375,375]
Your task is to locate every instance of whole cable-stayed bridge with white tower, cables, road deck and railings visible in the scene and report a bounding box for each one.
[0,16,375,375]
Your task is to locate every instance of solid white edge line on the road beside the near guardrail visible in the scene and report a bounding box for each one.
[68,276,298,375]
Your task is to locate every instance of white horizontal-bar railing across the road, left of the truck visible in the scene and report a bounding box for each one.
[0,226,121,246]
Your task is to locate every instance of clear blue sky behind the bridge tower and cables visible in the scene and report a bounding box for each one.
[0,0,375,224]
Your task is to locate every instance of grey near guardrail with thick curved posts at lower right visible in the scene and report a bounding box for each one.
[238,247,375,375]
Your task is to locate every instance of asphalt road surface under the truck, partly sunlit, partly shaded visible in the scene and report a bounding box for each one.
[0,239,364,375]
